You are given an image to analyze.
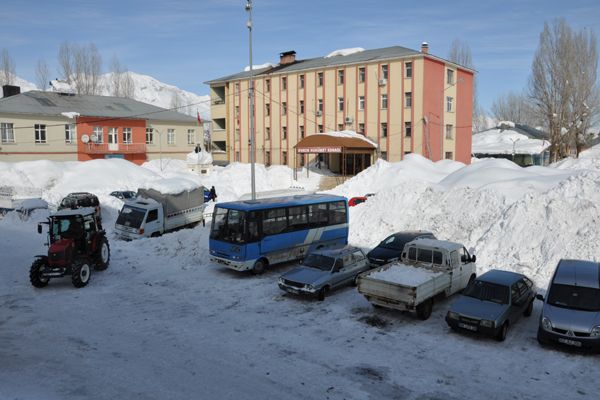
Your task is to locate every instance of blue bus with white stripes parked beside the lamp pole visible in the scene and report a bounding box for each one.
[209,194,348,274]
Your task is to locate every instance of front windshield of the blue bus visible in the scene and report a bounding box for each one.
[210,207,258,244]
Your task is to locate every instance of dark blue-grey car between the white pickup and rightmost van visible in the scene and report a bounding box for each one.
[446,269,535,342]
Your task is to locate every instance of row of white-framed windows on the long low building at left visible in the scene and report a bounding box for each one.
[0,122,197,144]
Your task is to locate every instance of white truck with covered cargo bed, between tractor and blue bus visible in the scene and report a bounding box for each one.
[115,187,206,240]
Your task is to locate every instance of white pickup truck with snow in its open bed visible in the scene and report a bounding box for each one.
[357,239,476,320]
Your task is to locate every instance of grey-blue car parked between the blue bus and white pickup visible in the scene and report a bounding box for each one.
[279,246,371,301]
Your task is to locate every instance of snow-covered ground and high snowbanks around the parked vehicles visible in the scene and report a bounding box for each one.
[0,153,600,399]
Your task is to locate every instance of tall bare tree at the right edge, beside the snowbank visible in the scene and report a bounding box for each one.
[529,19,598,161]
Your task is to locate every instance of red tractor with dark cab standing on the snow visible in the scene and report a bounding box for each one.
[29,207,110,288]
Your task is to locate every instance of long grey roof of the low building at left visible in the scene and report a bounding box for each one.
[0,90,196,123]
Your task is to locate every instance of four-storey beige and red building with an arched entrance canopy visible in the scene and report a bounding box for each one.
[206,43,474,169]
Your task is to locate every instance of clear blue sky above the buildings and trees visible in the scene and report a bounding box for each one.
[0,0,600,109]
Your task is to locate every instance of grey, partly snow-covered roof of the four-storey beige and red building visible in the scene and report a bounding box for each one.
[204,46,471,85]
